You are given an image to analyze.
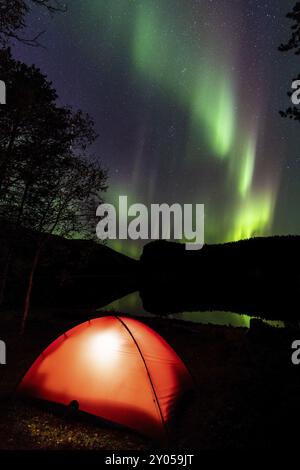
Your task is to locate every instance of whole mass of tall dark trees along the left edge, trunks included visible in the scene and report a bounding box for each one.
[0,50,106,328]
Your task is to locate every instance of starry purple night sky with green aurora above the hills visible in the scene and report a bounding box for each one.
[14,0,300,256]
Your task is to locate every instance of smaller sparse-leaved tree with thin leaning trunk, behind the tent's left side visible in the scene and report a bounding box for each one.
[21,152,106,332]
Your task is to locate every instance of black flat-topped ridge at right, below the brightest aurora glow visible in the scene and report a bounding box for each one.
[140,236,300,323]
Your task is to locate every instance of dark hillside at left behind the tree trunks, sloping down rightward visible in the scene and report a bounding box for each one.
[0,224,138,309]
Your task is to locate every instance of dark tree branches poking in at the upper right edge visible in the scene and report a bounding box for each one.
[279,2,300,121]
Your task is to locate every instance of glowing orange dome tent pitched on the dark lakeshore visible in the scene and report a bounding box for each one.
[19,316,192,438]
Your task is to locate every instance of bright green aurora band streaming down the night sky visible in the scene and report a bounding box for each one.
[81,0,278,257]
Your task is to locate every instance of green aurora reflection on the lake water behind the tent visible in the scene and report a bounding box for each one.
[98,292,285,328]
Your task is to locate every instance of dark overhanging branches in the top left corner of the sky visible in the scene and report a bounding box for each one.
[0,0,65,47]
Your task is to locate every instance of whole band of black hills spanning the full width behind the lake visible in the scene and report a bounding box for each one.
[0,230,300,324]
